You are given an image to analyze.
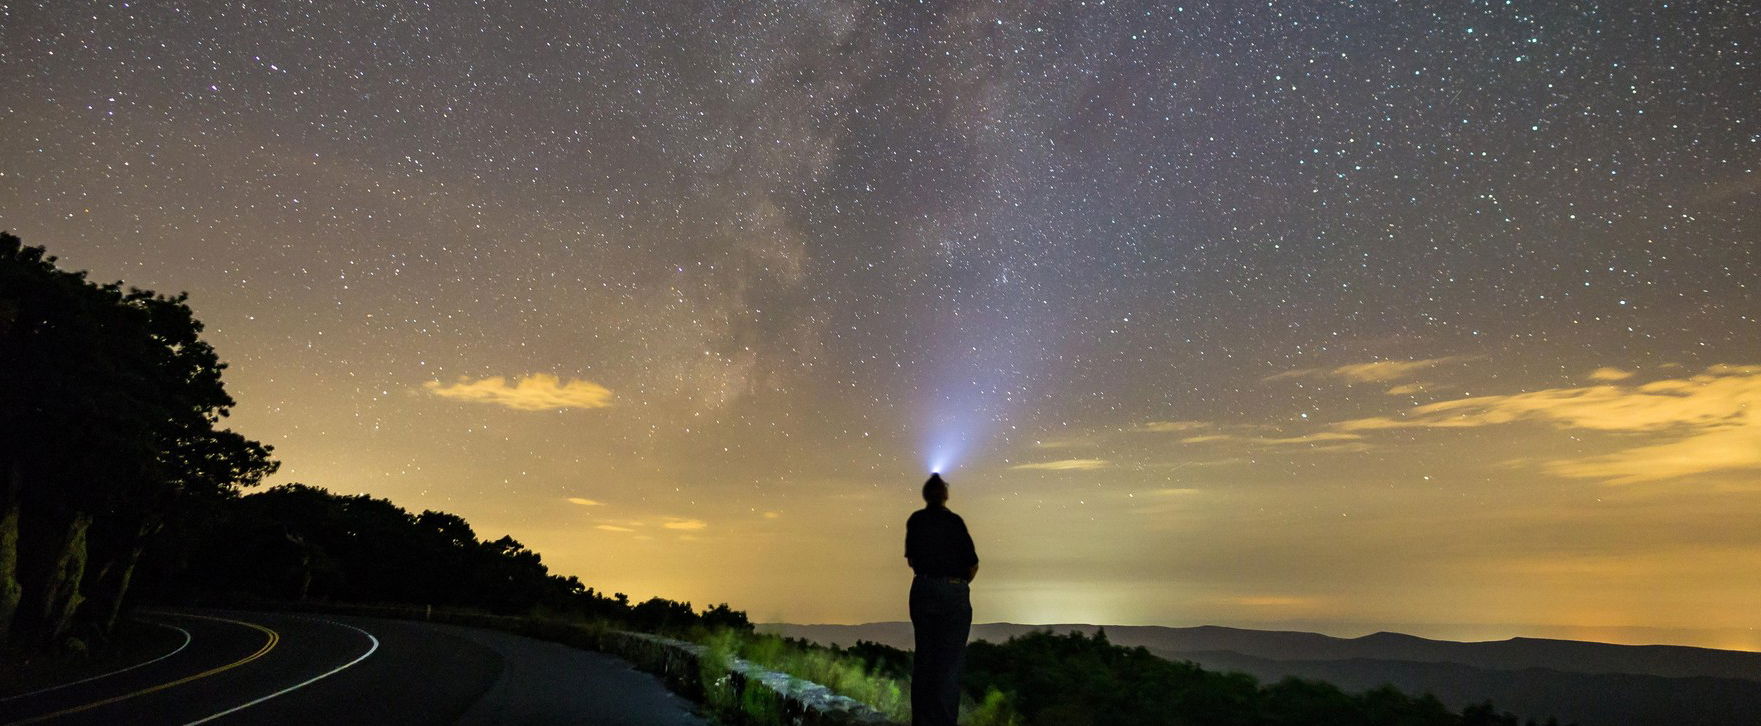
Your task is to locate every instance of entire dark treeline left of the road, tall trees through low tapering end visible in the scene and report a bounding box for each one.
[0,233,750,657]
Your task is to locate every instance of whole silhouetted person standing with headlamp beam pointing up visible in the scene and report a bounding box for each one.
[905,474,979,726]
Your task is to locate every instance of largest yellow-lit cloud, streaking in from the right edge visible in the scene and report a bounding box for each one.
[1333,365,1761,483]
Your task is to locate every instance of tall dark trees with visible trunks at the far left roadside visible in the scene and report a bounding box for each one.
[0,233,275,652]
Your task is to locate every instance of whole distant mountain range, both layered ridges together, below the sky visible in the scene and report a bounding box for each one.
[757,622,1761,726]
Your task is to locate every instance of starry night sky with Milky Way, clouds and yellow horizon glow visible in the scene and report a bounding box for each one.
[0,0,1761,648]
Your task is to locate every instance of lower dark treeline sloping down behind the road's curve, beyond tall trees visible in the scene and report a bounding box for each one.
[155,485,752,633]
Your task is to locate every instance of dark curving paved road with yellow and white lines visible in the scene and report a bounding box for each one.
[0,610,706,726]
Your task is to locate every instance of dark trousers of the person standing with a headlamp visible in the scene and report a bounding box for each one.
[910,578,972,726]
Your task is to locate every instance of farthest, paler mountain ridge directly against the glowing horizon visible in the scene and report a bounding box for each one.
[757,622,1761,682]
